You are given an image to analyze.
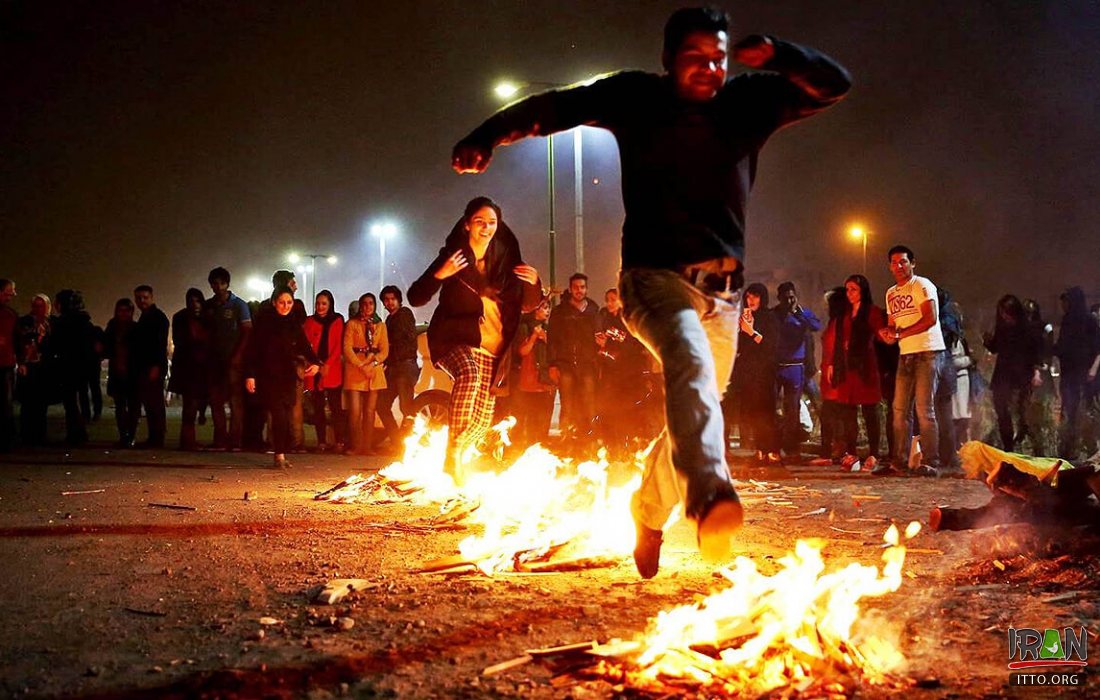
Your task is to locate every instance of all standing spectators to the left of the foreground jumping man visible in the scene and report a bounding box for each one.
[0,261,660,468]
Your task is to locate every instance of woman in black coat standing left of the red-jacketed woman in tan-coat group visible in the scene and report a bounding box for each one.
[244,286,321,469]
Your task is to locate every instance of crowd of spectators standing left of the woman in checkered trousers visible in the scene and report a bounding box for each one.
[0,267,420,467]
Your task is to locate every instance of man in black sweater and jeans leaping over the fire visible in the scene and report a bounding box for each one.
[453,8,850,579]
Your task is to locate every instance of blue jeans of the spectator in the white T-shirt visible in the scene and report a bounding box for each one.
[893,351,939,469]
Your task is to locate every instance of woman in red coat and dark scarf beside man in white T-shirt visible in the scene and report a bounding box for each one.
[822,275,887,469]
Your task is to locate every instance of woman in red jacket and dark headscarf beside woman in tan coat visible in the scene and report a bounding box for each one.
[303,289,345,452]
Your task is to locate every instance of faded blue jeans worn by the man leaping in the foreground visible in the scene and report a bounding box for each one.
[619,269,740,529]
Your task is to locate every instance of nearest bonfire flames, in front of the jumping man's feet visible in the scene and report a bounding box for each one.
[596,523,920,693]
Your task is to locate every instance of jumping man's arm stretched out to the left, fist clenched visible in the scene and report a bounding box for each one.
[451,73,638,173]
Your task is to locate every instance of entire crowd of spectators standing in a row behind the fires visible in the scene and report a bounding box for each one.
[0,245,1100,475]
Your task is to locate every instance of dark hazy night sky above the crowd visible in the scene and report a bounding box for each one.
[0,0,1100,324]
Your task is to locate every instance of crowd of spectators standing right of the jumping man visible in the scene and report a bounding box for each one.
[724,245,1100,475]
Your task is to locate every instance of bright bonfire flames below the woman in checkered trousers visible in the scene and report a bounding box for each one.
[319,418,641,576]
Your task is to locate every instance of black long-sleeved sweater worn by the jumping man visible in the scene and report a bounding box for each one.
[463,39,850,270]
